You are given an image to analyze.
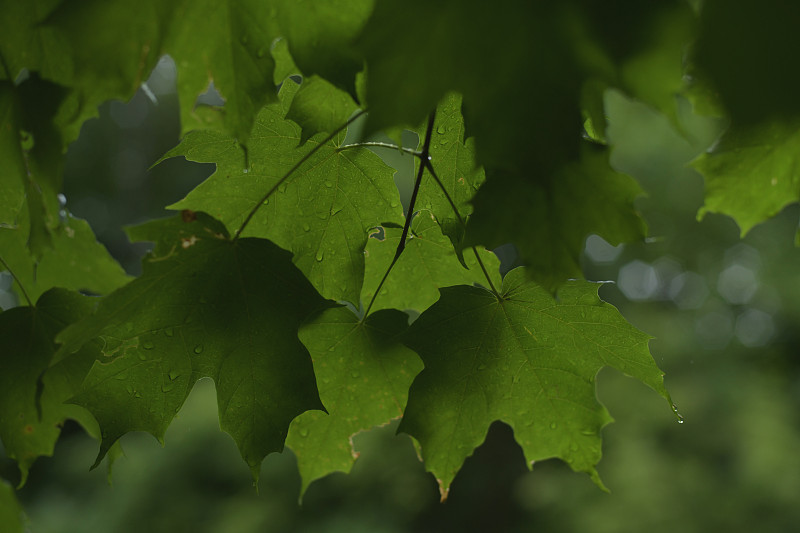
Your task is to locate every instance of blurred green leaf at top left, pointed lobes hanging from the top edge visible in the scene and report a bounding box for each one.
[46,0,279,142]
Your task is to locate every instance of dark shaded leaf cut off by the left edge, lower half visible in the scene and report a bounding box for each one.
[0,289,111,485]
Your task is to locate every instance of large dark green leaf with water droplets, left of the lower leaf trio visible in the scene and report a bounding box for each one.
[58,212,330,477]
